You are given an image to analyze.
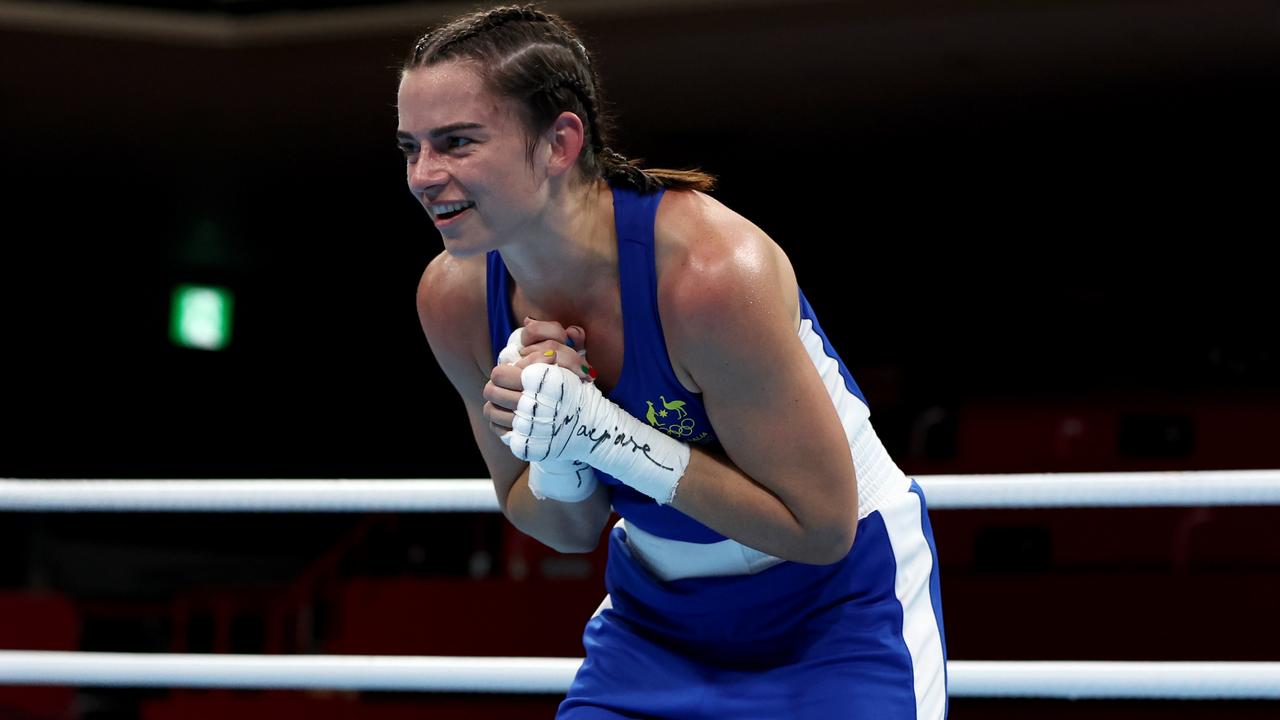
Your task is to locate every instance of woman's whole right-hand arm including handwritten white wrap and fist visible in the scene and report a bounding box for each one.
[486,229,858,564]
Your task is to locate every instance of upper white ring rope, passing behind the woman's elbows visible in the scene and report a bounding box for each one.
[0,470,1280,512]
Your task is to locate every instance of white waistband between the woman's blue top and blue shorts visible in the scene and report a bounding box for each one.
[617,420,910,582]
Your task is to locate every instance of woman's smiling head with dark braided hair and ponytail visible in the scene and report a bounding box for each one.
[397,15,713,254]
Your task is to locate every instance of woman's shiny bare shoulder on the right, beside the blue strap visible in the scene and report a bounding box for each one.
[654,191,799,346]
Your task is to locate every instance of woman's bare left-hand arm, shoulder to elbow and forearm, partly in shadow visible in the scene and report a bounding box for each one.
[417,254,609,552]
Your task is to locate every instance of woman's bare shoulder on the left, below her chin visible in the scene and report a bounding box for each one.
[417,252,492,382]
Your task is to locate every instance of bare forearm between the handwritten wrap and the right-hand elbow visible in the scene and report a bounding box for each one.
[671,447,856,565]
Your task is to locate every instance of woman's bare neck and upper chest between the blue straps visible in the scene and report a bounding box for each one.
[499,175,618,313]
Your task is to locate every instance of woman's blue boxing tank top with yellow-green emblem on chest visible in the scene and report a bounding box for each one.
[486,187,869,543]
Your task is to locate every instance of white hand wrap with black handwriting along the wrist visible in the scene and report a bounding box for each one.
[508,363,689,505]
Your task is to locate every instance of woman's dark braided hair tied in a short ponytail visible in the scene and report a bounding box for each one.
[403,5,716,192]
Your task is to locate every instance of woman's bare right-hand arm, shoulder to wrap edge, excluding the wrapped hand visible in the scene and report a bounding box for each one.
[663,215,858,564]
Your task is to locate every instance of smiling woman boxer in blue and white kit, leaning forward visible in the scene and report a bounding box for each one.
[397,6,946,720]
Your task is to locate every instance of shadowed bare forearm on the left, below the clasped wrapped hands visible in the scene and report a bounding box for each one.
[498,465,611,552]
